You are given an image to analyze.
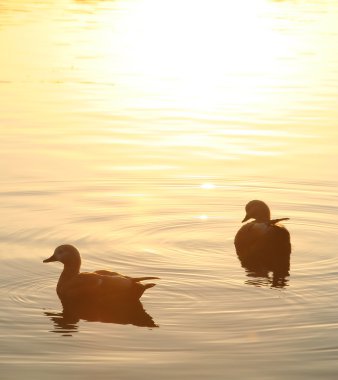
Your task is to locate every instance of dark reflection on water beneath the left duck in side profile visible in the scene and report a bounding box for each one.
[44,300,158,336]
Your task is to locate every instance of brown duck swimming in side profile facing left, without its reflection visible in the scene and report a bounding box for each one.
[43,244,158,306]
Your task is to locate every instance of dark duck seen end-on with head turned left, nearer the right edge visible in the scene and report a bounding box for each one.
[234,200,291,270]
